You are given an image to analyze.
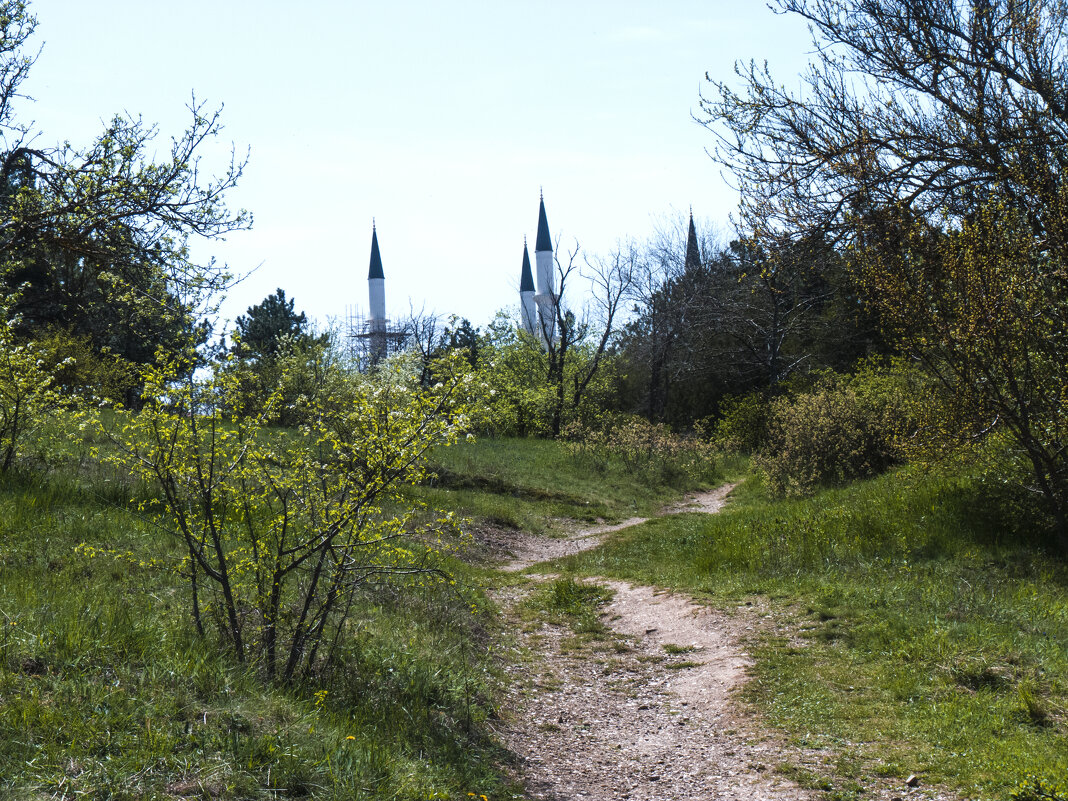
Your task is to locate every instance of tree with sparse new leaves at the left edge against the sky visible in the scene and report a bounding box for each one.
[0,0,250,380]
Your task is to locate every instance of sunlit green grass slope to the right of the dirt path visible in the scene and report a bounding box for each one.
[555,471,1068,798]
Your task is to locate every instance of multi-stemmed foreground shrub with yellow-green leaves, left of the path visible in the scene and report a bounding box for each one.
[91,348,468,680]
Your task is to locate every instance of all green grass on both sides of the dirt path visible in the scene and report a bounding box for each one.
[0,420,1068,800]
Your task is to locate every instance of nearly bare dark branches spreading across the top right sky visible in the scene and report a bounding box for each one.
[702,0,1068,248]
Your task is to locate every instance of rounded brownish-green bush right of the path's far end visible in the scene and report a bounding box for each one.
[754,364,915,496]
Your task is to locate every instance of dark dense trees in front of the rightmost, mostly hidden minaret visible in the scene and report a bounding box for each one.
[623,223,878,426]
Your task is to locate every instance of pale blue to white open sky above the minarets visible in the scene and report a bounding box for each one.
[20,0,810,325]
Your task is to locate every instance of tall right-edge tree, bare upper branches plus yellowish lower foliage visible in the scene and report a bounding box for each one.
[703,0,1068,551]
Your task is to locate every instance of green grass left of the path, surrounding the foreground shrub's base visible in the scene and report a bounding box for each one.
[0,442,509,799]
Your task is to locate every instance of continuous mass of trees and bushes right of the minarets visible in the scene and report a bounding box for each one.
[390,0,1068,551]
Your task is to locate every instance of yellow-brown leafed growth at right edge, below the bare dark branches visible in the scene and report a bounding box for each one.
[858,195,1068,552]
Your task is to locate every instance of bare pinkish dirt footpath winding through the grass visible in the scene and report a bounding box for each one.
[484,486,951,801]
